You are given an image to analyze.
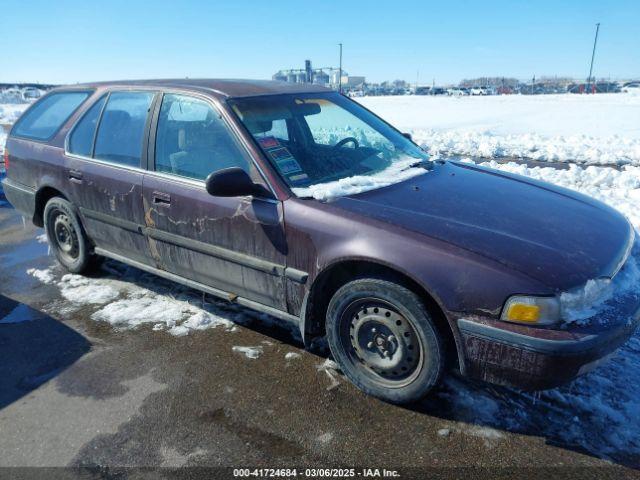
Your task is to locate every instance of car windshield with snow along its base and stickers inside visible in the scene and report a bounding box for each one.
[229,92,431,199]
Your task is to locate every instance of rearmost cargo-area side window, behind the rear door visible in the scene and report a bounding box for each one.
[11,92,90,140]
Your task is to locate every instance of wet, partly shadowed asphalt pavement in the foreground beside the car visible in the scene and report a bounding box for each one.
[0,205,640,478]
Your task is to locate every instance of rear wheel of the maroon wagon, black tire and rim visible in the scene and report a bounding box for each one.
[43,197,101,273]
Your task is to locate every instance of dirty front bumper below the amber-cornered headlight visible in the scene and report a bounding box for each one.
[457,296,640,390]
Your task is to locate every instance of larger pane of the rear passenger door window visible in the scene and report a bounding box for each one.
[94,92,154,167]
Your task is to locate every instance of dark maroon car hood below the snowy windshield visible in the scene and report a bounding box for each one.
[334,162,632,293]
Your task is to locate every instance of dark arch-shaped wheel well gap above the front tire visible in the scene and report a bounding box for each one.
[300,258,460,368]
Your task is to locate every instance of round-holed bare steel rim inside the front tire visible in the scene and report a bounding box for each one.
[341,298,424,388]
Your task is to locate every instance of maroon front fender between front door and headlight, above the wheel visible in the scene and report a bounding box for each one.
[285,199,553,344]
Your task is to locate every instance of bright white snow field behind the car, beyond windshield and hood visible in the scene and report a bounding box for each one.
[358,94,640,165]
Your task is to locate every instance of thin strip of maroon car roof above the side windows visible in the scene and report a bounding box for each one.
[60,78,332,98]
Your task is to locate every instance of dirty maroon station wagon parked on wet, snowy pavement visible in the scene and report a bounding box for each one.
[3,80,640,403]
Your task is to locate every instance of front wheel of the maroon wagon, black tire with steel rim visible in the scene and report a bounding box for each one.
[326,278,445,404]
